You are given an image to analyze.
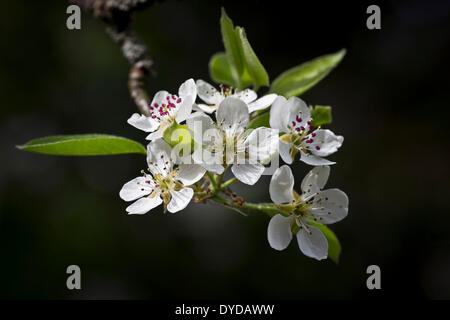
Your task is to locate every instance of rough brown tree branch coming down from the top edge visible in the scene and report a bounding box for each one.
[69,0,156,115]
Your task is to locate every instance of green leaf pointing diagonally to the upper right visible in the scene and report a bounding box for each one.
[270,49,345,98]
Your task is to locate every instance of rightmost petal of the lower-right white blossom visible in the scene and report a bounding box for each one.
[310,189,348,224]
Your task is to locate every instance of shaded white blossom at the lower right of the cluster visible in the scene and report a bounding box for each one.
[267,165,348,260]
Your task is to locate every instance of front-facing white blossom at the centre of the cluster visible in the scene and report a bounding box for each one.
[186,97,279,185]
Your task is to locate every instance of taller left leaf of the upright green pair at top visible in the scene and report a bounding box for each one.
[220,8,244,87]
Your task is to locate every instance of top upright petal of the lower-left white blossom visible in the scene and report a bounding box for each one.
[147,139,173,176]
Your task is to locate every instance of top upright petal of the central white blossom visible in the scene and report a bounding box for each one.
[216,97,249,132]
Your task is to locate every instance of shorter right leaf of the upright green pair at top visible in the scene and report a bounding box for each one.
[236,27,269,91]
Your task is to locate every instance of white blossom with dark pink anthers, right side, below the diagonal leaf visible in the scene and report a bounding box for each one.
[270,96,344,166]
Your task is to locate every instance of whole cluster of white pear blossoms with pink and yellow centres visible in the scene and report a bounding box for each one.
[120,79,348,260]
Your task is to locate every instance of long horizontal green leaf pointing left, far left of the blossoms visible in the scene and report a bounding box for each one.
[17,134,147,156]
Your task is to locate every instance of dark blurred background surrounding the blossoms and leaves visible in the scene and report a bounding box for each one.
[0,0,450,300]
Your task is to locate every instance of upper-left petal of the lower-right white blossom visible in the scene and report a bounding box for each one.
[269,165,294,204]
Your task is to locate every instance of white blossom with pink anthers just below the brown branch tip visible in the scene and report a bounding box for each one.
[128,79,197,140]
